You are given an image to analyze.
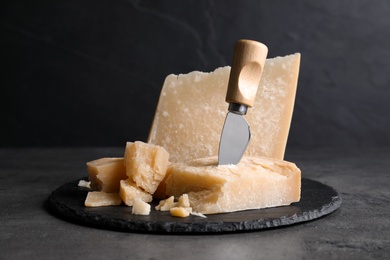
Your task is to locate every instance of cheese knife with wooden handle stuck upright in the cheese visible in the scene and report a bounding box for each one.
[218,39,268,165]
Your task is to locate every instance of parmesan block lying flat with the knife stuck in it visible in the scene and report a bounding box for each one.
[166,156,301,214]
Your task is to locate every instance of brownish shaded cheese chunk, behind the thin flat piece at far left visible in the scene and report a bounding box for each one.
[87,158,127,192]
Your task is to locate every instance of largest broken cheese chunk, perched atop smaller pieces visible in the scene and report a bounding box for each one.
[124,141,169,194]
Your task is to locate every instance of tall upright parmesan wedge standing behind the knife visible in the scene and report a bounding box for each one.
[148,53,300,162]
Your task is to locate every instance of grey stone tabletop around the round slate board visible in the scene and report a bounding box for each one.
[0,148,390,260]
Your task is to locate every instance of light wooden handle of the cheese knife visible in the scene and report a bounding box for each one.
[226,40,268,107]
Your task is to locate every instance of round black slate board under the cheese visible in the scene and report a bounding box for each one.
[47,178,341,233]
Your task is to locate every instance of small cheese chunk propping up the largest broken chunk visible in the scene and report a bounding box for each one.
[119,178,153,206]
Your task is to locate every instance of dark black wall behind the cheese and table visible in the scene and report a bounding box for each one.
[0,0,390,149]
